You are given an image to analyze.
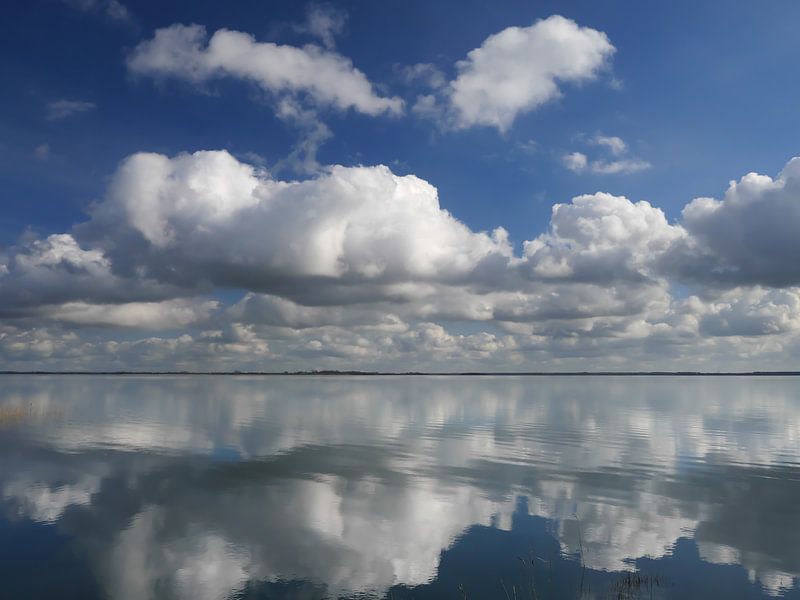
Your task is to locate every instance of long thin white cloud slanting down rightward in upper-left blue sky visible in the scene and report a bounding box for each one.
[128,25,403,115]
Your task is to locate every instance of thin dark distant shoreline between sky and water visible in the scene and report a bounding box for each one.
[0,370,800,377]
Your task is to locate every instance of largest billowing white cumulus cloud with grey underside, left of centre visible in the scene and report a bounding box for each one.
[80,151,511,298]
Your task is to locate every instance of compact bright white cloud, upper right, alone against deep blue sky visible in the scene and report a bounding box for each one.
[438,15,614,131]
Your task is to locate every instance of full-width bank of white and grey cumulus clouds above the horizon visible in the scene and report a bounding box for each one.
[0,146,800,369]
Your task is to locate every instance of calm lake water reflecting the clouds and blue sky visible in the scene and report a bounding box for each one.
[0,376,800,600]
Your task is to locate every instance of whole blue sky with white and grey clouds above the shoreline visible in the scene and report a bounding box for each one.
[0,0,800,371]
